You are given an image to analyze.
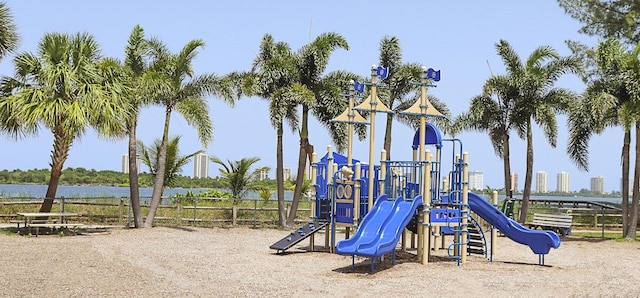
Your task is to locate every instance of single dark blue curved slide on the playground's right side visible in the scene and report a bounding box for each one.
[469,192,560,255]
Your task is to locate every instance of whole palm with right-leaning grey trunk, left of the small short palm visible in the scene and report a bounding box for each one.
[144,39,235,228]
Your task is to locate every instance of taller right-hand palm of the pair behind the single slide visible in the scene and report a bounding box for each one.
[496,40,581,223]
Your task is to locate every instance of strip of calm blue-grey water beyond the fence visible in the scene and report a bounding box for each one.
[0,184,621,203]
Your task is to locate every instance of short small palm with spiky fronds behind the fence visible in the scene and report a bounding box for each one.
[211,157,260,225]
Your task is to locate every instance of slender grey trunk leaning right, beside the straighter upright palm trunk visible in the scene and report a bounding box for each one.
[144,107,171,228]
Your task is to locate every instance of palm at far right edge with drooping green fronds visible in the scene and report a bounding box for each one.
[567,39,640,239]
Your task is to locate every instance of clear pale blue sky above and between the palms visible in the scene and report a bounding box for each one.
[0,0,622,191]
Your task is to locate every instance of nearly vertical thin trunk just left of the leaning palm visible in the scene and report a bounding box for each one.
[128,115,142,228]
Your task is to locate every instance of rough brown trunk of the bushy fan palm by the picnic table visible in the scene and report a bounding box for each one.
[40,127,73,212]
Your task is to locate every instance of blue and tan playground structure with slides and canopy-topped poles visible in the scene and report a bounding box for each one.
[271,66,560,271]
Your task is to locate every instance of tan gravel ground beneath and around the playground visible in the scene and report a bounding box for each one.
[0,227,640,297]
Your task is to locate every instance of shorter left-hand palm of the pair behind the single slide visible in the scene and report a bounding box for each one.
[454,76,518,195]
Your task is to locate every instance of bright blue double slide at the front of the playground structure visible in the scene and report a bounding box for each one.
[336,195,422,257]
